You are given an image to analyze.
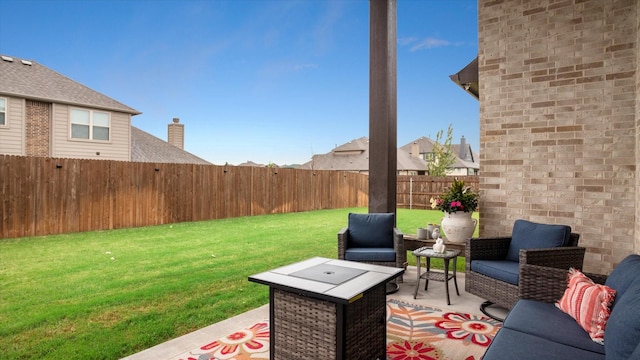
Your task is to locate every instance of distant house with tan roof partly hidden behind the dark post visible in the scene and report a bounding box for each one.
[298,137,427,175]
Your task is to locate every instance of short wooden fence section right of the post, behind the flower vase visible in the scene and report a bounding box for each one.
[396,175,480,210]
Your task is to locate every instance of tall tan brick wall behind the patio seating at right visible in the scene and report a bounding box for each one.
[478,0,640,272]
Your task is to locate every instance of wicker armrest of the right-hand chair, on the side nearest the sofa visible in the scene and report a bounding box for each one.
[519,246,586,270]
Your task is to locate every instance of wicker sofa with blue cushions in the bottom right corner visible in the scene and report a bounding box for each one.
[483,254,640,360]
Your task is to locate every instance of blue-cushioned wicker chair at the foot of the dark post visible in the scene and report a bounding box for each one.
[338,213,407,291]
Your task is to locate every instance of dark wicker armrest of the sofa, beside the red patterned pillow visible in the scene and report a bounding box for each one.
[518,263,569,303]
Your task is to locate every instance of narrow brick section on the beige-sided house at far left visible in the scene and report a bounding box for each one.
[25,100,51,156]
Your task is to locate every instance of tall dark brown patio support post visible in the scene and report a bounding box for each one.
[369,0,398,213]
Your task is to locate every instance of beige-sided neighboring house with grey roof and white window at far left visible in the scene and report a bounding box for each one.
[0,55,207,163]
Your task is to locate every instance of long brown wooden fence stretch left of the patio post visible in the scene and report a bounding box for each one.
[0,155,369,238]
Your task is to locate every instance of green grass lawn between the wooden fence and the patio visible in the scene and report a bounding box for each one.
[0,208,478,359]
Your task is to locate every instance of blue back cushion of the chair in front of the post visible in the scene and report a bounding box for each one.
[347,213,395,248]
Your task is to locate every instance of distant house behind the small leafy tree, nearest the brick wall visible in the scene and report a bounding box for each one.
[400,136,480,176]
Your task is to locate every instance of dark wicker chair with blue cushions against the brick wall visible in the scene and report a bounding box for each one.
[465,220,586,320]
